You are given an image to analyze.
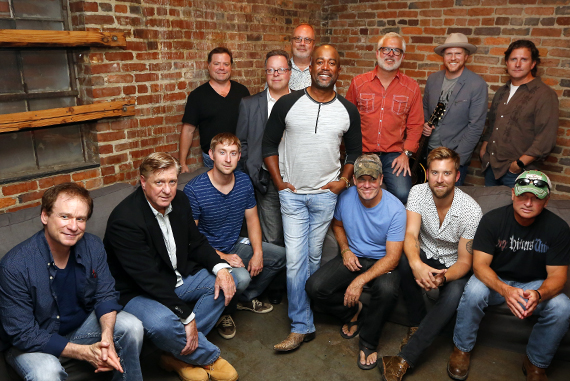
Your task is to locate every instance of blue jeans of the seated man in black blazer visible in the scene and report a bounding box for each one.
[125,269,231,365]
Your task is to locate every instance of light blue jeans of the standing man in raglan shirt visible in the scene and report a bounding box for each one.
[279,189,337,334]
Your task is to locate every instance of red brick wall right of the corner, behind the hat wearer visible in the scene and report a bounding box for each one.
[322,0,570,194]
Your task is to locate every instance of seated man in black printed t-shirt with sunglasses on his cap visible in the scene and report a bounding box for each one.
[447,171,570,380]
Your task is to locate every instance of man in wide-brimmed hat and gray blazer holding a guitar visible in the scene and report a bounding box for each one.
[423,33,488,185]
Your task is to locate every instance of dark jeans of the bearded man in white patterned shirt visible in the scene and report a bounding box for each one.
[398,250,471,367]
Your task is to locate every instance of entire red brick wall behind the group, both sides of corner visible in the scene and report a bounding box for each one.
[0,0,570,213]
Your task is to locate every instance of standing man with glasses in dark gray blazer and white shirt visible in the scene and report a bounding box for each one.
[236,50,291,246]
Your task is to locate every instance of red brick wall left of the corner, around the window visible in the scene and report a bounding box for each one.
[0,0,322,213]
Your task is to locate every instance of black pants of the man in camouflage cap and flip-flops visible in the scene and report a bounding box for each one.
[305,255,400,349]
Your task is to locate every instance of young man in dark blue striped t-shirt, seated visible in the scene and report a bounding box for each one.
[184,133,285,339]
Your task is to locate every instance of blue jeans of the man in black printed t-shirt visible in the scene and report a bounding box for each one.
[453,275,570,368]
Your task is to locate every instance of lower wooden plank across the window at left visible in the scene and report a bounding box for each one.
[0,99,135,133]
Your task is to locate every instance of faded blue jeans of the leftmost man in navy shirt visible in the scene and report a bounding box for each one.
[6,312,143,381]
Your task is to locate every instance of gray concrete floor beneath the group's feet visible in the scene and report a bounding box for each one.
[143,302,570,381]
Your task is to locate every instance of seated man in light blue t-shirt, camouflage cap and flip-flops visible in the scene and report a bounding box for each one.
[305,155,406,370]
